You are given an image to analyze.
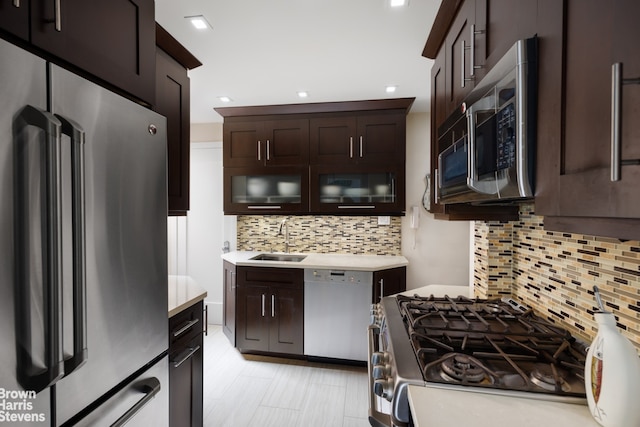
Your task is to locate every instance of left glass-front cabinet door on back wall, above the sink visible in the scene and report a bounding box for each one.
[224,168,309,214]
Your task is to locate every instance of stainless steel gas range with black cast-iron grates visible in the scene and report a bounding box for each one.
[369,295,586,427]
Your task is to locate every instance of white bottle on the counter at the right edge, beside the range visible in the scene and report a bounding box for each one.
[584,312,640,427]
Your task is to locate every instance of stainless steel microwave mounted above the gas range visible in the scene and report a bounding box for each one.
[436,38,537,204]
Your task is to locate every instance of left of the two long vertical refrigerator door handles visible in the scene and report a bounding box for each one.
[14,105,64,392]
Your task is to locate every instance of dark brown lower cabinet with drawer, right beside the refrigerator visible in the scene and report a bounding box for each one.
[169,301,204,427]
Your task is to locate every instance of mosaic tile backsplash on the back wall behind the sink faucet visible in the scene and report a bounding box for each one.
[237,215,402,255]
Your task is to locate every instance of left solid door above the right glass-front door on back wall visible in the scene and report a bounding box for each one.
[309,117,357,164]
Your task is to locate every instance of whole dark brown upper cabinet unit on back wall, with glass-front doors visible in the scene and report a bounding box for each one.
[216,98,413,215]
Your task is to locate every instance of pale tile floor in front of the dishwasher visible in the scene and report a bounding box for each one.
[204,325,369,427]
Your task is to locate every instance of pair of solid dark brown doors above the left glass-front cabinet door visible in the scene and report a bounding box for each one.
[222,119,309,167]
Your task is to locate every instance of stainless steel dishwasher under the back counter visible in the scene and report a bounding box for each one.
[304,269,373,362]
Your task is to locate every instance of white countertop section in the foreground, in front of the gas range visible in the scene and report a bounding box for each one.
[408,386,599,427]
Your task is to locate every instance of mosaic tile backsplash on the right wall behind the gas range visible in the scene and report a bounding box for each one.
[474,204,640,350]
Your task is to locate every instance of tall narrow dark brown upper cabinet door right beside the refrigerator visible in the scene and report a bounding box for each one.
[155,49,190,215]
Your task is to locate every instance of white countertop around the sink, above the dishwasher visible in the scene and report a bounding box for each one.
[222,251,409,271]
